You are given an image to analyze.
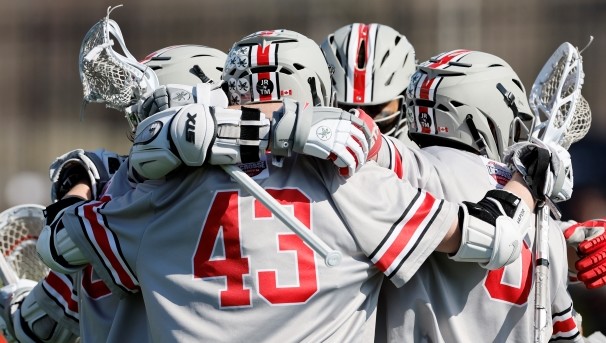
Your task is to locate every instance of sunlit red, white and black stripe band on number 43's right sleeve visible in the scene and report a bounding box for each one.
[369,190,444,277]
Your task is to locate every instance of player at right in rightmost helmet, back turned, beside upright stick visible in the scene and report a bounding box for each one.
[377,50,582,342]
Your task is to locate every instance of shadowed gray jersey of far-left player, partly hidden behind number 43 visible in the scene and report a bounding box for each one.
[33,163,149,343]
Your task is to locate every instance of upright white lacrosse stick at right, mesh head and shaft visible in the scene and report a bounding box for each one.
[529,37,593,343]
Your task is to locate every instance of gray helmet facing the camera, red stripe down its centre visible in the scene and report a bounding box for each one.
[321,23,415,136]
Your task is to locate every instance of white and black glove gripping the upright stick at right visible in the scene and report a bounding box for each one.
[503,142,574,202]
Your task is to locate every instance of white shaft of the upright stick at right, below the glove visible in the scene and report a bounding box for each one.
[534,204,551,343]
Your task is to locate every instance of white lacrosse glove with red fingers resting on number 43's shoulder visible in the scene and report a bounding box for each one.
[271,99,382,176]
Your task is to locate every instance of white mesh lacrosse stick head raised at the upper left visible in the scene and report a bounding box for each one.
[78,6,158,129]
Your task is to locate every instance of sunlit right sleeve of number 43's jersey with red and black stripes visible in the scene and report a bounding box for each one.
[320,162,458,287]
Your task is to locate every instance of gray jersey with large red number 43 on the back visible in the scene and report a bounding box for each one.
[58,156,458,342]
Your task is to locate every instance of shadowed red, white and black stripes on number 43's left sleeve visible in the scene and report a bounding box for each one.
[76,197,139,293]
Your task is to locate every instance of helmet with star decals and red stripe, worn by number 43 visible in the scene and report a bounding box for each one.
[223,30,332,106]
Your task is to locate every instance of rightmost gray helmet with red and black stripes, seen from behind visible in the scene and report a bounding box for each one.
[406,50,534,161]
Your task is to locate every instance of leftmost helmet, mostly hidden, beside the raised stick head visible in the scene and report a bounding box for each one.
[141,45,227,86]
